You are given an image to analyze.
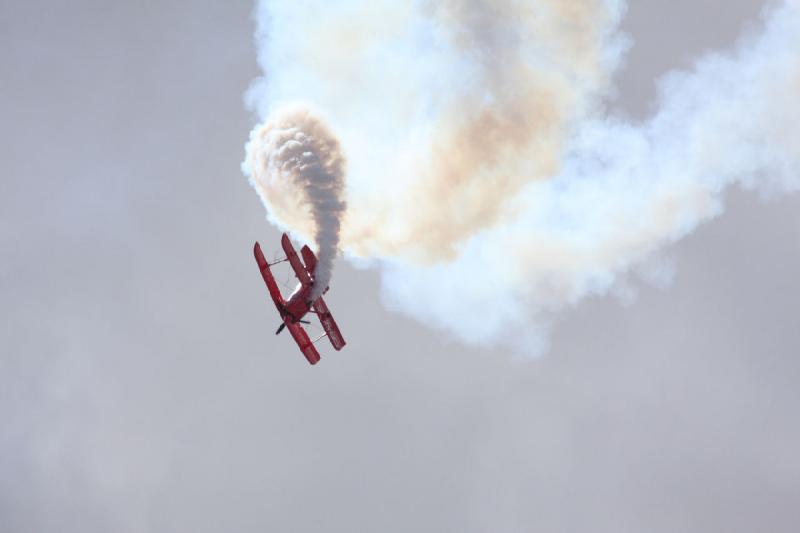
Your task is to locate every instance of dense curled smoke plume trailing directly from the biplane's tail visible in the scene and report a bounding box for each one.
[244,107,345,300]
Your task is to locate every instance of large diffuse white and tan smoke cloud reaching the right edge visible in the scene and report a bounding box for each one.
[251,0,800,352]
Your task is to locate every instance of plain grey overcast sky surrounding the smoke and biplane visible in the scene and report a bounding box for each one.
[0,0,800,533]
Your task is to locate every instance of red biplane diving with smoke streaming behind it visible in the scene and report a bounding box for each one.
[253,233,345,365]
